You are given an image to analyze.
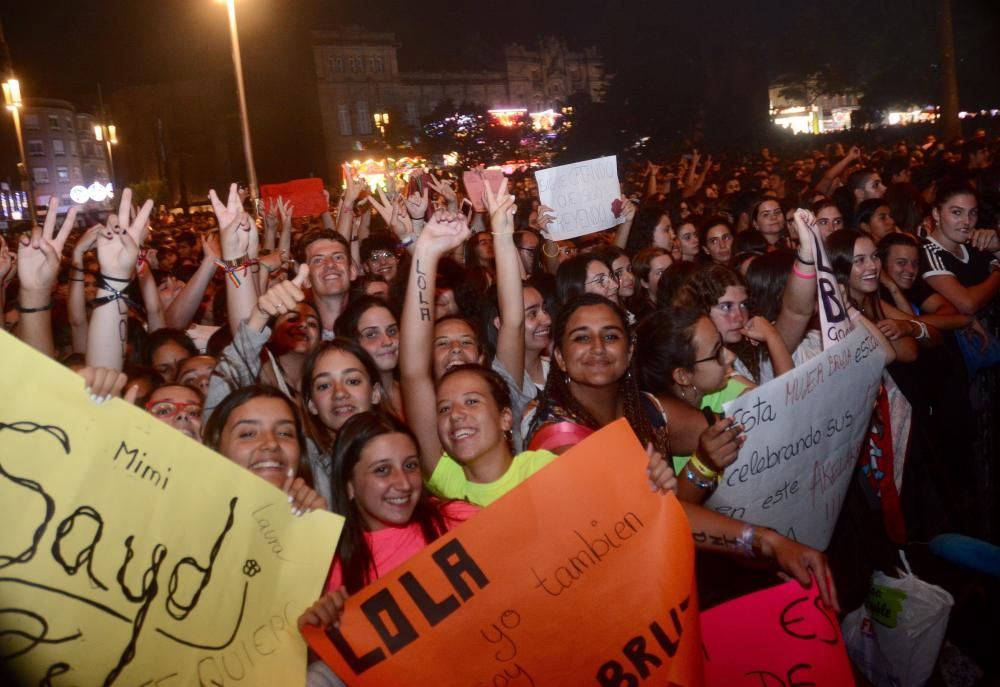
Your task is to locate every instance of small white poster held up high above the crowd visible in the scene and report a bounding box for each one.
[535,155,625,241]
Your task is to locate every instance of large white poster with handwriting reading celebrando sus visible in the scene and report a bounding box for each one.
[706,327,885,550]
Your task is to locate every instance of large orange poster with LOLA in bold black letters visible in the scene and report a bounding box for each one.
[306,420,702,687]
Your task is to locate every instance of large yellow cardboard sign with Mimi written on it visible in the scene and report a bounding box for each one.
[0,332,343,687]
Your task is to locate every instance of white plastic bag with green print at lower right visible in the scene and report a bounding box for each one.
[841,551,955,687]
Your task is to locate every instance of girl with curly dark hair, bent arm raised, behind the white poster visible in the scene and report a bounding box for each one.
[675,263,794,383]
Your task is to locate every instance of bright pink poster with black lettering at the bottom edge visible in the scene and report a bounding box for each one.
[701,581,854,687]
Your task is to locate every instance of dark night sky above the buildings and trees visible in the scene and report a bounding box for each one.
[0,0,1000,183]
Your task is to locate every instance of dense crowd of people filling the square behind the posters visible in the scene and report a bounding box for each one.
[0,127,1000,684]
